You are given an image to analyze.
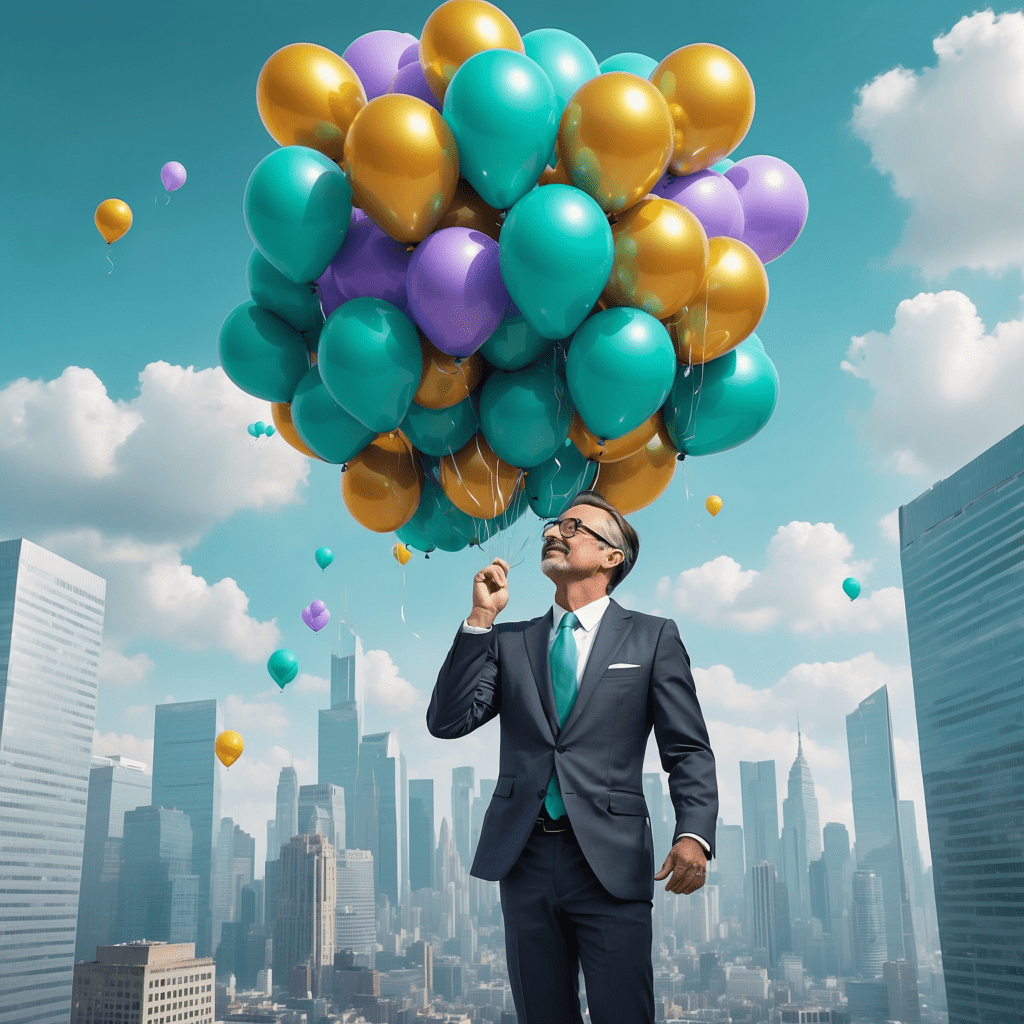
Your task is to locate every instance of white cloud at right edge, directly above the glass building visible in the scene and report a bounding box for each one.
[841,291,1024,476]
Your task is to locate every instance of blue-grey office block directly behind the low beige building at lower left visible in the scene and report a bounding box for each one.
[116,806,200,943]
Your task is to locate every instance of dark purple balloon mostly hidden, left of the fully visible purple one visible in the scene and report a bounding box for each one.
[316,220,411,316]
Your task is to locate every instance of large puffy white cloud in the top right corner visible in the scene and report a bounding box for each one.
[852,10,1024,276]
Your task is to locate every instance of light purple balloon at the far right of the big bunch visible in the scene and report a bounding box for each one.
[725,157,807,263]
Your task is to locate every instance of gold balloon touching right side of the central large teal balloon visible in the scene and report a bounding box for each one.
[602,196,708,319]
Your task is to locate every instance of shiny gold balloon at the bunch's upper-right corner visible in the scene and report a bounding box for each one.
[650,43,754,174]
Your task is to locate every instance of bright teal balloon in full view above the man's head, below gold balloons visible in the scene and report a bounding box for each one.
[569,309,676,440]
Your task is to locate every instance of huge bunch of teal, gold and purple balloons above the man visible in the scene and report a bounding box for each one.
[219,0,807,551]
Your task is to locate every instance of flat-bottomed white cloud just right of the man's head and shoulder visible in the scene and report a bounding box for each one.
[657,521,904,634]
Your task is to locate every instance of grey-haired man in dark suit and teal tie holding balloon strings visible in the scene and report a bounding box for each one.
[427,492,718,1024]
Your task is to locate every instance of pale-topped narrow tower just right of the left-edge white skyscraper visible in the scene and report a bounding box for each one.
[75,755,153,961]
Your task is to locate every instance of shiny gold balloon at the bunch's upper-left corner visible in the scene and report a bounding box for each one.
[256,43,367,160]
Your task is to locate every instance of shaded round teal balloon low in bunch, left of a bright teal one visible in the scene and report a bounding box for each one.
[480,362,572,469]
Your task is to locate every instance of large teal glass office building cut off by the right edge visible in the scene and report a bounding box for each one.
[901,419,1024,1024]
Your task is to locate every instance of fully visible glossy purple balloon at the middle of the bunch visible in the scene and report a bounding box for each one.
[409,227,509,356]
